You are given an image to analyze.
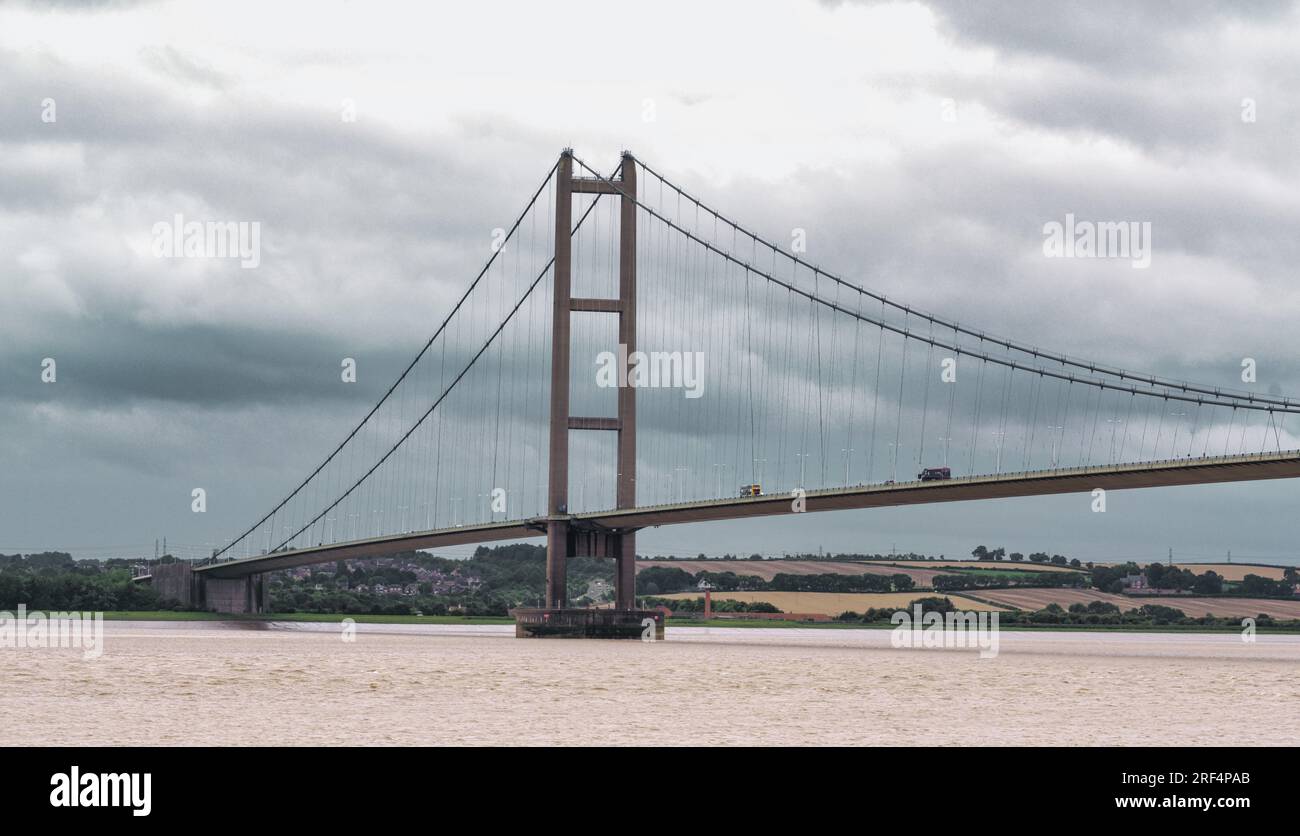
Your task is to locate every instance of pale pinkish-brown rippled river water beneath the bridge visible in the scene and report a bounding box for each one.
[0,621,1300,746]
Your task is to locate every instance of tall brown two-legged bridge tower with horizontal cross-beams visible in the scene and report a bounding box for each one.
[546,148,637,610]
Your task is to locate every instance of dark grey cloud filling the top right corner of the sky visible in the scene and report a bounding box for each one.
[878,0,1300,170]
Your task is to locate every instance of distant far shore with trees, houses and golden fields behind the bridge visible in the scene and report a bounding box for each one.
[0,543,1300,627]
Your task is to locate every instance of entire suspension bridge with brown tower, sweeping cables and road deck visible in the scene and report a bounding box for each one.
[142,150,1300,624]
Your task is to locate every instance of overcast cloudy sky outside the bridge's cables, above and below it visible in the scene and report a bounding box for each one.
[0,0,1300,559]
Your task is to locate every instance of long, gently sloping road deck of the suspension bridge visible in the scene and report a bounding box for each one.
[195,450,1300,577]
